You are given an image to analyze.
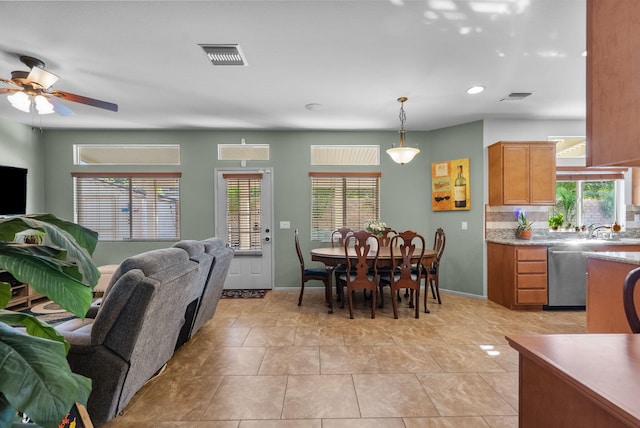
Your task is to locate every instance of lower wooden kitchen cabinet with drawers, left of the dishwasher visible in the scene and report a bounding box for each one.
[487,242,547,310]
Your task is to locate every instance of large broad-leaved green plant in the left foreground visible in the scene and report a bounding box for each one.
[0,214,100,428]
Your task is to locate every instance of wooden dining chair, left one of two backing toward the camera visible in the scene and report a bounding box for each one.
[336,230,380,319]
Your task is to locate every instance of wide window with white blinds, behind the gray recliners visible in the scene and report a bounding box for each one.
[72,173,181,241]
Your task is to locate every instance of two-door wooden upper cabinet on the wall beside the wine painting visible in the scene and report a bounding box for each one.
[489,141,556,205]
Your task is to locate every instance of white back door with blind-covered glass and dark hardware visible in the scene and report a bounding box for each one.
[215,168,273,290]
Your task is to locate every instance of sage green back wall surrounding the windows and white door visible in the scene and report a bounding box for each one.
[44,130,456,288]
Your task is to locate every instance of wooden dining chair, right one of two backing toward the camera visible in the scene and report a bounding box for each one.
[380,230,425,319]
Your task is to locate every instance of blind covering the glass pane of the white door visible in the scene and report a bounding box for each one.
[222,174,262,254]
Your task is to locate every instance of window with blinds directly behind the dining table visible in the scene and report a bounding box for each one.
[309,172,380,241]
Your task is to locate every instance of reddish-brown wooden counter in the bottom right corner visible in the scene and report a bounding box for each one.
[507,334,640,428]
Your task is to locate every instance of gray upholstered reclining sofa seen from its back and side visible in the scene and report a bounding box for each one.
[56,238,233,426]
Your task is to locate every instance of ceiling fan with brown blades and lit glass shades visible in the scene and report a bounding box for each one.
[0,55,118,116]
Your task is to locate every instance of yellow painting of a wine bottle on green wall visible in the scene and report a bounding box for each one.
[431,158,471,211]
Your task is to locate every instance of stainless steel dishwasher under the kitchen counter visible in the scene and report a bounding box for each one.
[545,243,593,309]
